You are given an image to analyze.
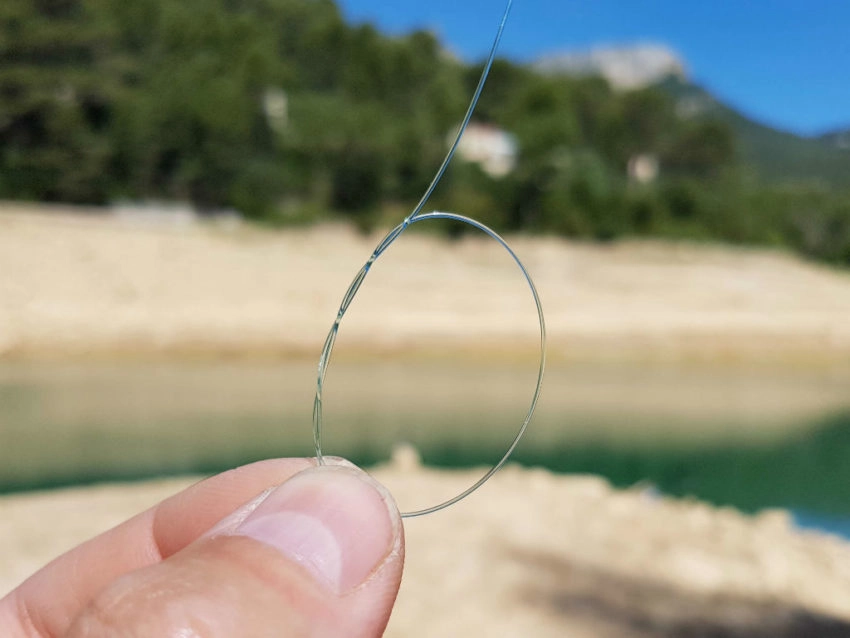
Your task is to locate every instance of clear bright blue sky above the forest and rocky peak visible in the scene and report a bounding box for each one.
[339,0,850,134]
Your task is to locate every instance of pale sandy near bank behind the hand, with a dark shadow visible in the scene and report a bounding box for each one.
[0,454,850,638]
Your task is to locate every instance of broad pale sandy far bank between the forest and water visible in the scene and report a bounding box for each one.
[0,204,850,363]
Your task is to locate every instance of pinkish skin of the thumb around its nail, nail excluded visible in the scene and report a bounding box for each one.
[62,480,404,638]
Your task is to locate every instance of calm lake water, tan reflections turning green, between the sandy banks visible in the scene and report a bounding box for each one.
[0,358,850,533]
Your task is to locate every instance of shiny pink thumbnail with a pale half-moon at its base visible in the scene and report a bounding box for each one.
[233,466,401,594]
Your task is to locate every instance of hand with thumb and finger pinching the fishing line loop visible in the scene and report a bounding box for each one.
[0,459,404,638]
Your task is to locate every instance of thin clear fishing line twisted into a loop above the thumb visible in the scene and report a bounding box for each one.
[313,0,546,518]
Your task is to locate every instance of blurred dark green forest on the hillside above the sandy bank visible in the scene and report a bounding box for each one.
[0,0,850,265]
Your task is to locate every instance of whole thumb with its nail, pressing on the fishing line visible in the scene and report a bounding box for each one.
[67,466,404,638]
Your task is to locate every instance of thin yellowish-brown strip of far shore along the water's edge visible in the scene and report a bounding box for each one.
[0,332,850,372]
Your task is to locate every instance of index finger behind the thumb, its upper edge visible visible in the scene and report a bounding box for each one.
[0,459,315,638]
